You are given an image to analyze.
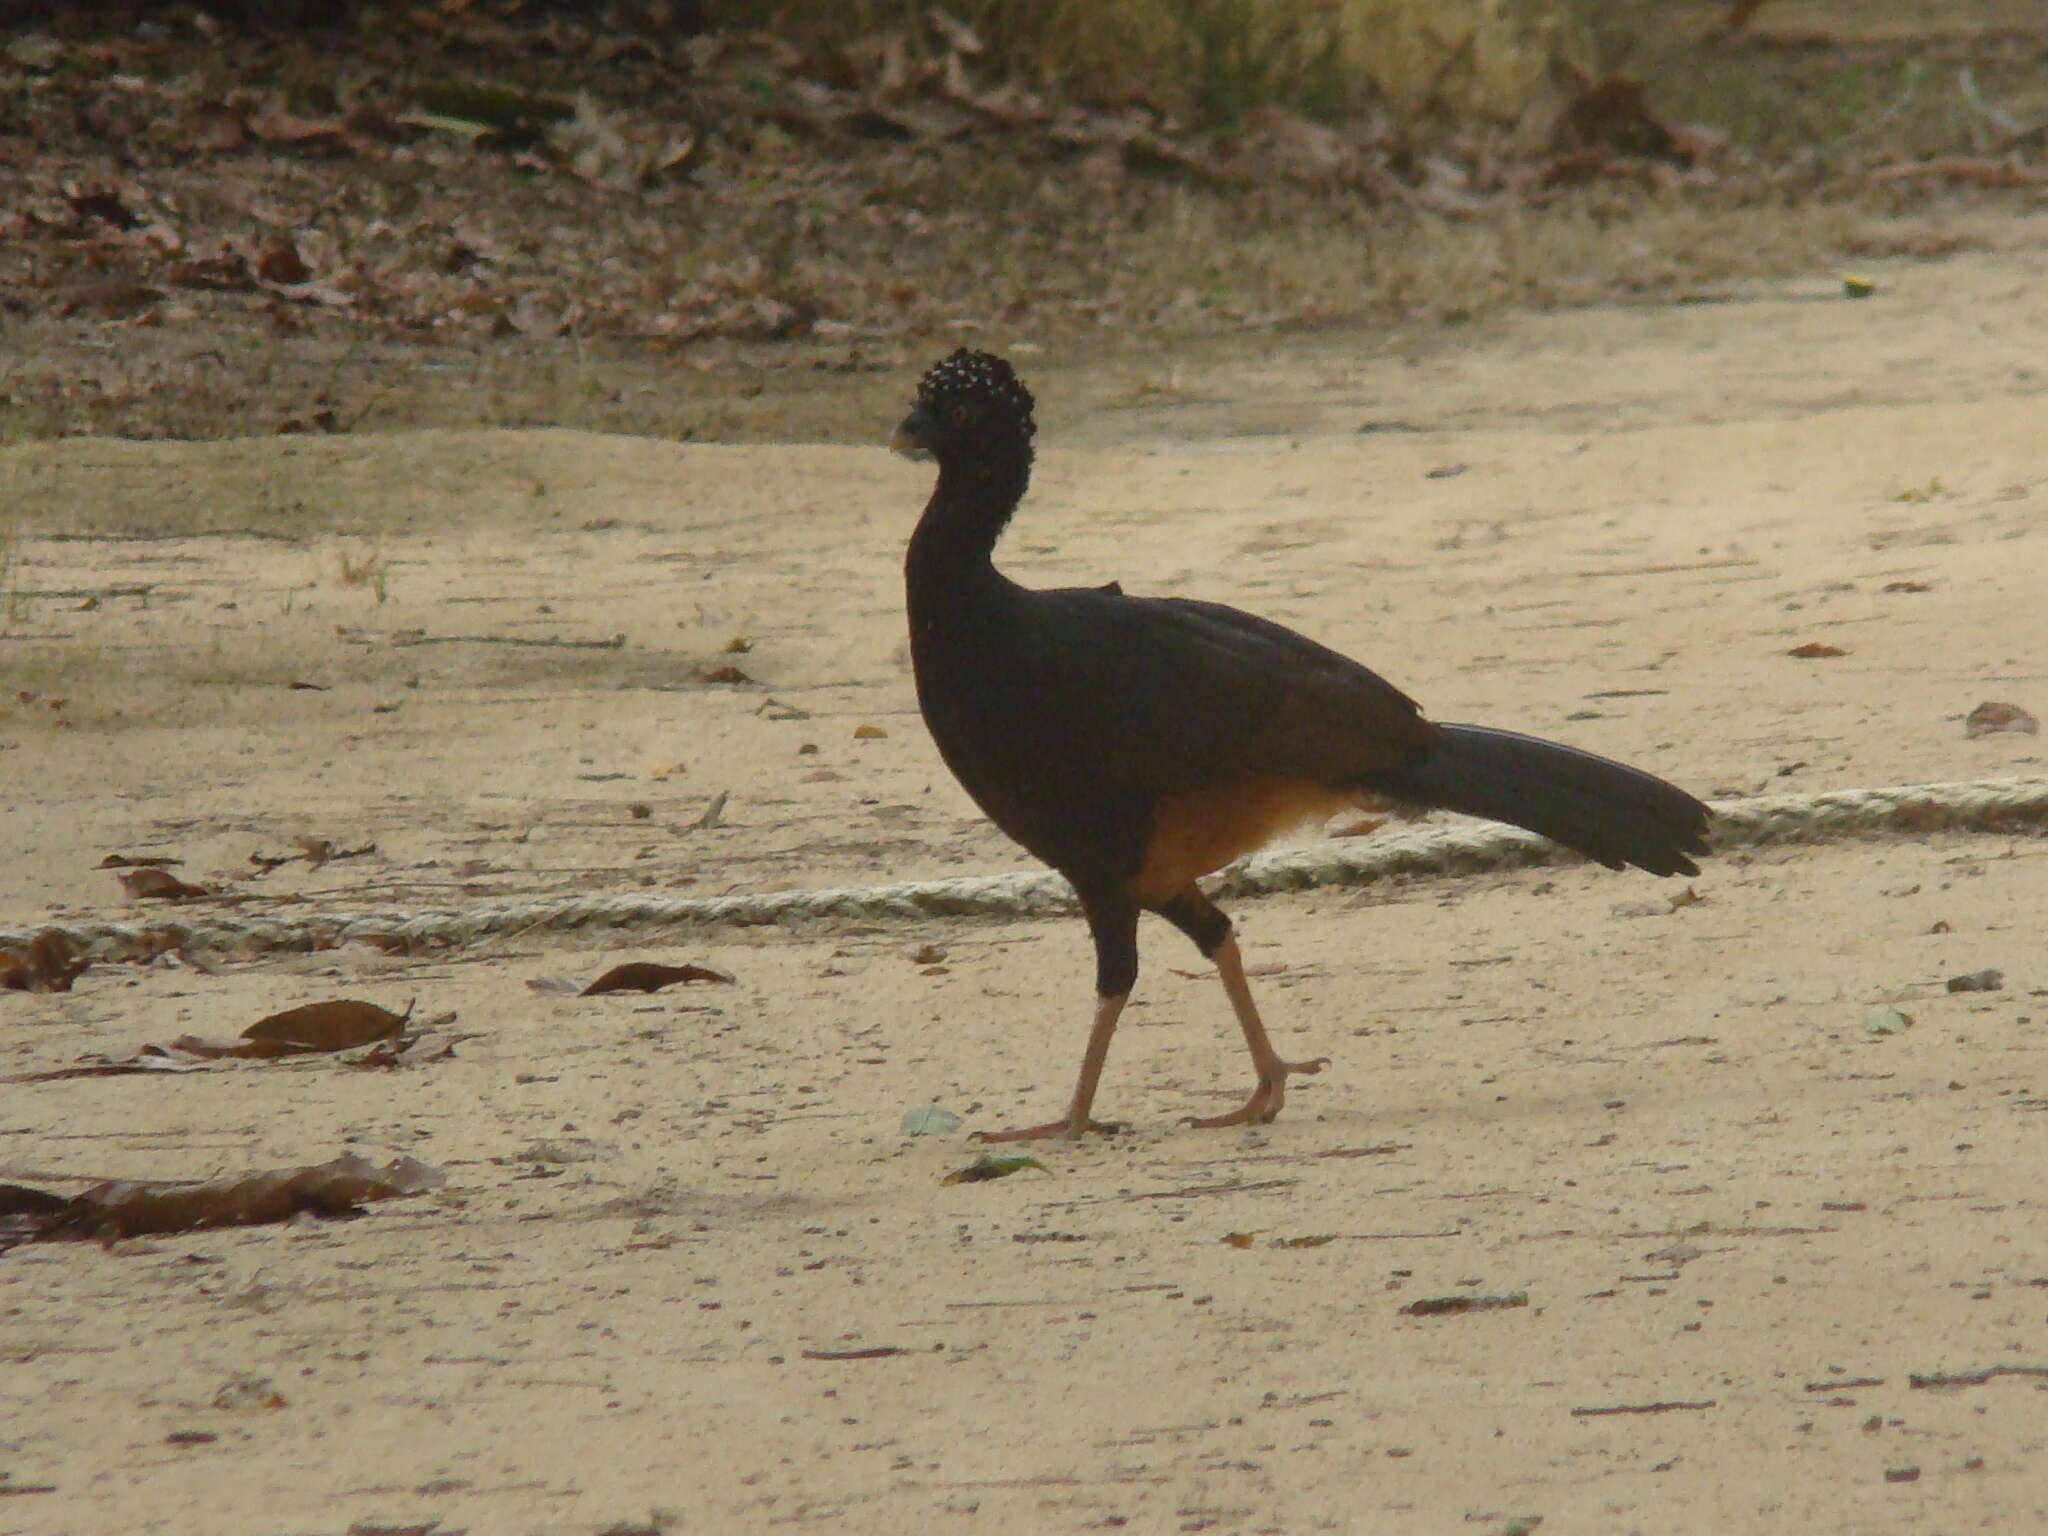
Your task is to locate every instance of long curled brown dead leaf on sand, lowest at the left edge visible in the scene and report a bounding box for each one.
[0,1153,449,1241]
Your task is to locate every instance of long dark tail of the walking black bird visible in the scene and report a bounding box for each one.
[1366,725,1712,874]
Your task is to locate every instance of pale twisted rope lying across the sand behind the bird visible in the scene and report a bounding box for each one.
[16,778,2048,958]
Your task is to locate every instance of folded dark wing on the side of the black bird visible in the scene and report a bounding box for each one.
[1018,588,1430,793]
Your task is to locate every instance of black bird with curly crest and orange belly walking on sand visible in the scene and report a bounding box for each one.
[891,348,1710,1141]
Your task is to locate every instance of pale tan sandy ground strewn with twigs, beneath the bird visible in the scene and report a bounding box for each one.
[0,228,2048,1534]
